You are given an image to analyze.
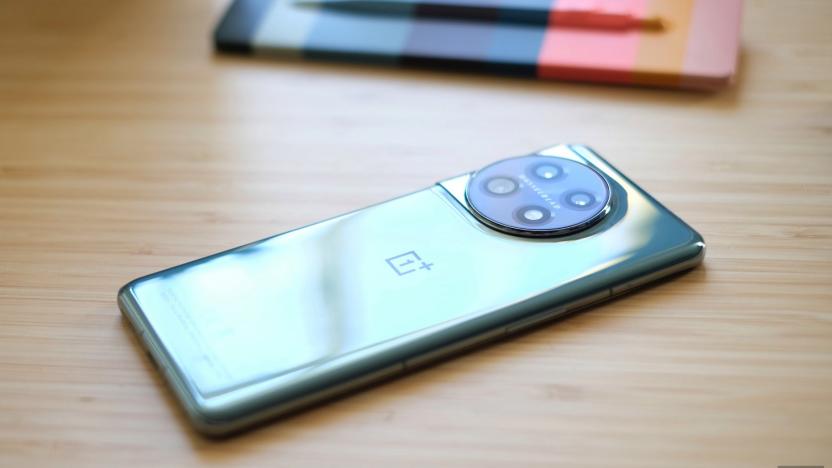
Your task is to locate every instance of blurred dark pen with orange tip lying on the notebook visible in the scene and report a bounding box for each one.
[295,0,663,30]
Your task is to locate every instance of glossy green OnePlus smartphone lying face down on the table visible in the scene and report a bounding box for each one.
[118,145,705,435]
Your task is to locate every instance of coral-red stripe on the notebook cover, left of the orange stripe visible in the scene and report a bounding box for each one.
[537,0,648,83]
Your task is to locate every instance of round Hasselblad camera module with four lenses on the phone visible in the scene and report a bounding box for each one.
[465,155,611,237]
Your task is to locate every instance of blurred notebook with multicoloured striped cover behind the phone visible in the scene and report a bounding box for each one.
[214,0,742,90]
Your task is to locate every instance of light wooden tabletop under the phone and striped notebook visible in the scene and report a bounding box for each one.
[0,0,832,468]
